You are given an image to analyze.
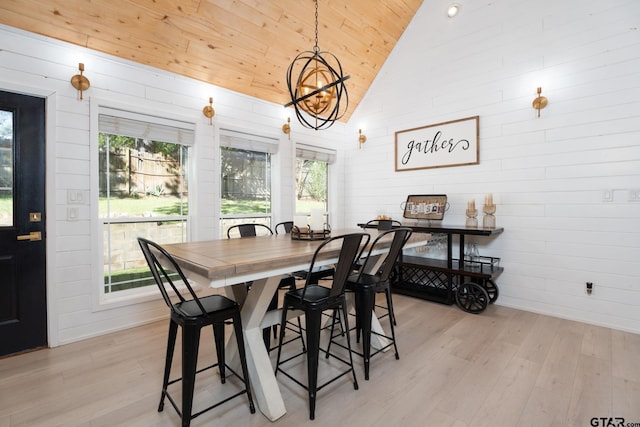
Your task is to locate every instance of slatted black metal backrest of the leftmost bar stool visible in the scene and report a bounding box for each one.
[138,237,207,315]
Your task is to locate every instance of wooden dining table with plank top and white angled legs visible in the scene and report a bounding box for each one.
[164,228,430,421]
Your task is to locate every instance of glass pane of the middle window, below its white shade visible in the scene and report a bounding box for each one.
[220,147,271,215]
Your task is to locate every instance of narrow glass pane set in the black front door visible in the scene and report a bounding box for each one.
[0,110,13,227]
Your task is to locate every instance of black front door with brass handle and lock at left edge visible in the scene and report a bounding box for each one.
[0,91,47,356]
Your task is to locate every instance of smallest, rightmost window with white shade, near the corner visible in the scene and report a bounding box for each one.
[296,144,335,213]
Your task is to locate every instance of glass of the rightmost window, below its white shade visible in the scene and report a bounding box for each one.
[296,158,328,212]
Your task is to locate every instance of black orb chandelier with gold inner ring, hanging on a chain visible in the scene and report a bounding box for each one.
[285,0,349,130]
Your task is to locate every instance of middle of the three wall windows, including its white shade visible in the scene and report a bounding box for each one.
[220,129,278,238]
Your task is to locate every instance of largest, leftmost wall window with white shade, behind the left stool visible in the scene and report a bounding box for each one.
[98,107,193,294]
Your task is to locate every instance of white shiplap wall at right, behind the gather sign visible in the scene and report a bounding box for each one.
[345,0,640,332]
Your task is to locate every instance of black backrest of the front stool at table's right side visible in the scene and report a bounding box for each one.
[302,233,370,299]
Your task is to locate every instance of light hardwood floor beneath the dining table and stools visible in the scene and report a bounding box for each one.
[0,295,640,427]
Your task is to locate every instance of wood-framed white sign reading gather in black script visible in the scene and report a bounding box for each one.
[396,116,480,171]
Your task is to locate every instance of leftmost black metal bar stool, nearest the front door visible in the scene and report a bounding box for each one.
[138,237,256,427]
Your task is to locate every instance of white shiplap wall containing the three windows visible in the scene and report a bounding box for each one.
[0,26,344,346]
